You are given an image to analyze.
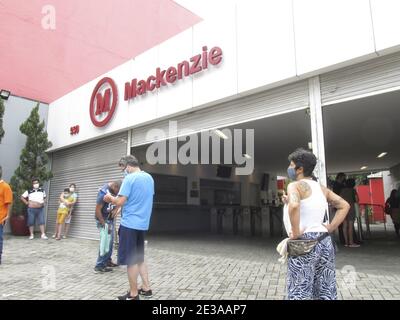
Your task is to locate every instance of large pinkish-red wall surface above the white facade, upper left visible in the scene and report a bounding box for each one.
[0,0,200,103]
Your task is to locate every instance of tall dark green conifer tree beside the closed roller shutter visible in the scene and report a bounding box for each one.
[10,103,53,214]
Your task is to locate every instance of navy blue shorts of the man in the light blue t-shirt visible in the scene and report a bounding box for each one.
[118,225,145,266]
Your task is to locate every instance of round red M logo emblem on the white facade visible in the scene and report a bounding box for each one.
[89,78,118,127]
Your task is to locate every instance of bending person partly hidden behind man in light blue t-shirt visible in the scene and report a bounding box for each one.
[94,181,121,273]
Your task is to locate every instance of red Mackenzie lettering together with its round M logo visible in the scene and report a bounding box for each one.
[89,46,222,127]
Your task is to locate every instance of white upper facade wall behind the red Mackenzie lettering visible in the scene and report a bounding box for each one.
[48,0,400,149]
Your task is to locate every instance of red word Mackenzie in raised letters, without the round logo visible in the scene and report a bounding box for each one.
[124,46,222,100]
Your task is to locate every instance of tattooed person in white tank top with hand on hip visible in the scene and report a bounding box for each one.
[284,149,350,300]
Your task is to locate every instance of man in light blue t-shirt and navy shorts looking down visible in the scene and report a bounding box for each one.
[104,155,154,300]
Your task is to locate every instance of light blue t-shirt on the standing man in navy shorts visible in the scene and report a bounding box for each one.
[119,171,154,230]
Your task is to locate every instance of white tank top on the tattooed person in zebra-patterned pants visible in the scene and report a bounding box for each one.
[283,179,328,235]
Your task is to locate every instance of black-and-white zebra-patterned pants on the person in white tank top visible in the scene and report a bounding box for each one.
[286,232,337,300]
